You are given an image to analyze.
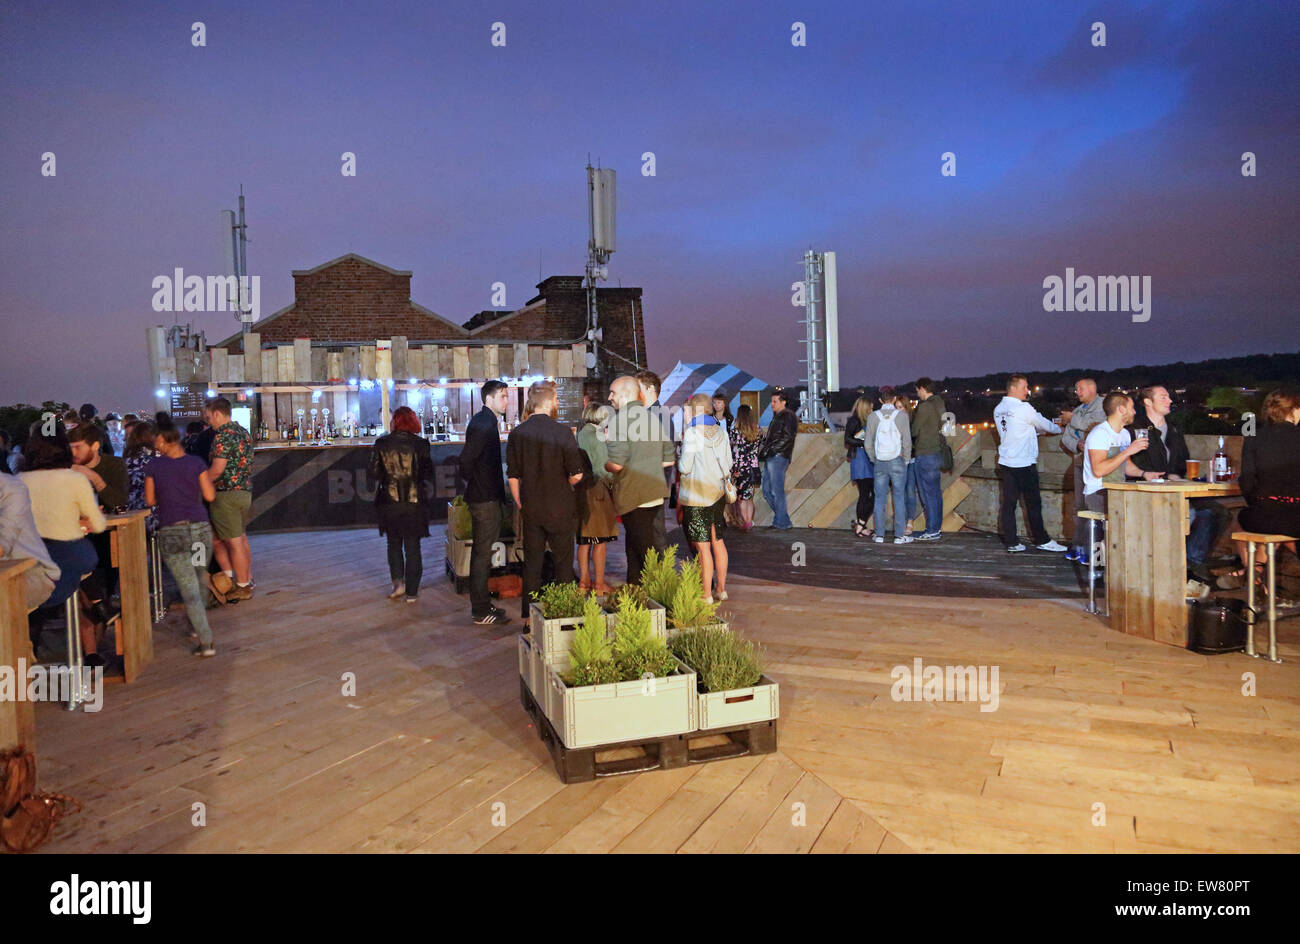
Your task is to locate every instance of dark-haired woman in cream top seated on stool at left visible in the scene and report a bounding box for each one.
[18,420,108,666]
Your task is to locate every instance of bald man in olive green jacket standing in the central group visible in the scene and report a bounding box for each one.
[605,377,677,584]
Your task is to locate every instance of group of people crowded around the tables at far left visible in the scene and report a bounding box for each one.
[0,397,254,670]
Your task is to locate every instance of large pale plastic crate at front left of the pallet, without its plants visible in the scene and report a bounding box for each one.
[546,658,699,748]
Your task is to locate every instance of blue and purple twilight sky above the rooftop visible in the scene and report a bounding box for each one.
[0,0,1300,411]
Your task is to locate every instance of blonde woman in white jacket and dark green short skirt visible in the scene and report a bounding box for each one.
[677,394,732,603]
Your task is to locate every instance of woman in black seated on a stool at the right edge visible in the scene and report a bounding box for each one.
[1236,387,1300,598]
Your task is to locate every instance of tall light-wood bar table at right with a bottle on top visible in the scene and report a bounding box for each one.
[1106,481,1242,648]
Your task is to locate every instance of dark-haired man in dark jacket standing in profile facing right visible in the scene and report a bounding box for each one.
[462,380,510,625]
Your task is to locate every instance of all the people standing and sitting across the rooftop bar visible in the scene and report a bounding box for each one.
[0,371,1300,664]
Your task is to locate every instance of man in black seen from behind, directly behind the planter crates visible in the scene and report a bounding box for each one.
[506,381,582,619]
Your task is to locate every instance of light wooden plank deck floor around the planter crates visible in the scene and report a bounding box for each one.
[30,531,1300,853]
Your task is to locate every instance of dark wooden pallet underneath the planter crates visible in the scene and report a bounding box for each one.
[519,677,776,783]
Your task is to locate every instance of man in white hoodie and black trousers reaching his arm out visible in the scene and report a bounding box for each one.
[993,373,1067,554]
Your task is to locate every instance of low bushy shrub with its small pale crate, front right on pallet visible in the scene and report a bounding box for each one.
[668,625,780,731]
